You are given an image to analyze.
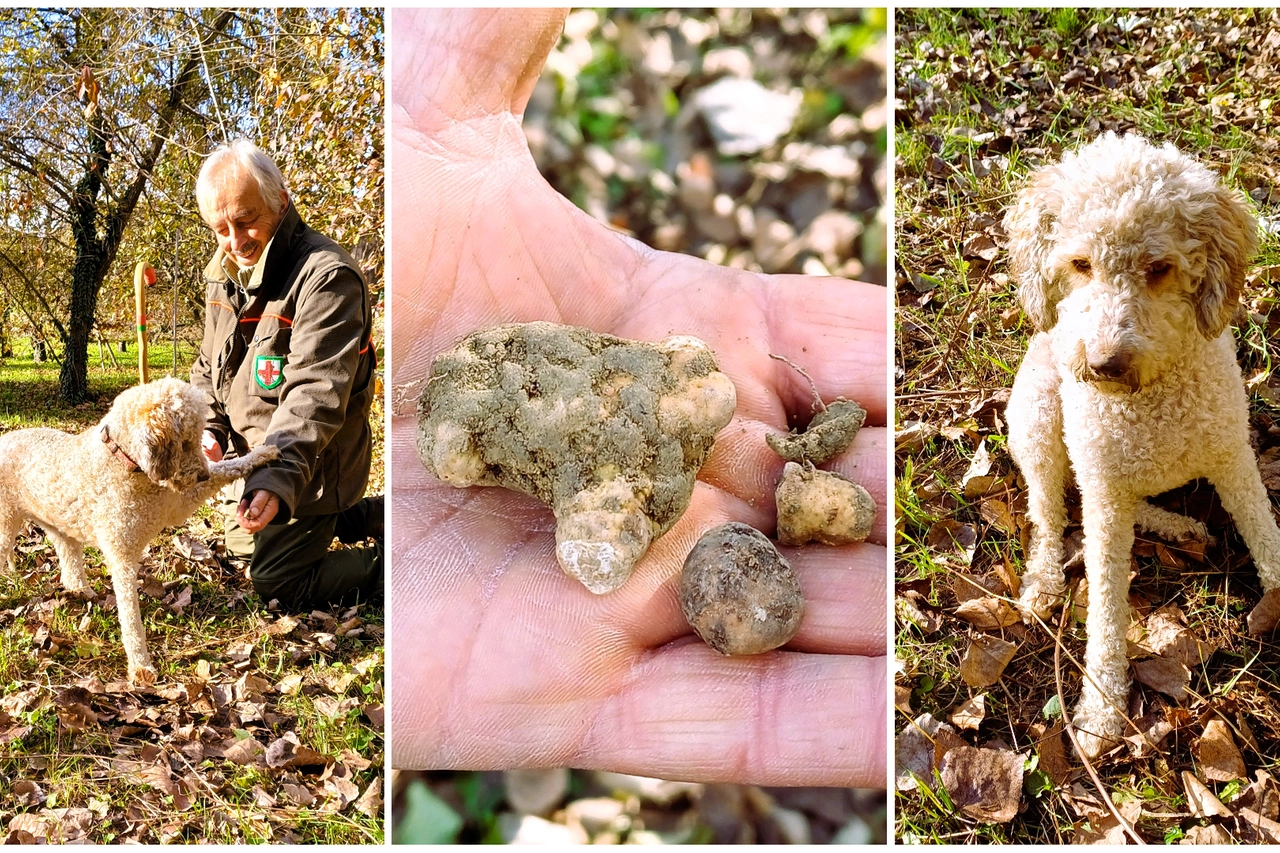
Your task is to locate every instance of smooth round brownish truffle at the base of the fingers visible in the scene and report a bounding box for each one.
[680,521,804,654]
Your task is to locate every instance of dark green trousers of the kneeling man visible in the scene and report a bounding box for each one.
[223,498,383,610]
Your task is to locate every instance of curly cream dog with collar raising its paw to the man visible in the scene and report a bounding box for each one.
[0,379,279,685]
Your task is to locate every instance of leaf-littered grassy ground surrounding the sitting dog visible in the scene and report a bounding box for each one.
[895,9,1280,843]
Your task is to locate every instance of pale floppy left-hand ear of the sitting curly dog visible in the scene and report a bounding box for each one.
[1005,167,1065,332]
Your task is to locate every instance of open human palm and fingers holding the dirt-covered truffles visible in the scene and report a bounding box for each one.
[390,10,887,786]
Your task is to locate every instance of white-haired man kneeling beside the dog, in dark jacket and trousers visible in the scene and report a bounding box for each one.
[191,140,383,608]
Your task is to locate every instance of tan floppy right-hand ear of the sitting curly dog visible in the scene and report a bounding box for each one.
[1190,186,1258,341]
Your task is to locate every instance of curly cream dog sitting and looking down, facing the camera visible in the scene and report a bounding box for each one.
[1005,133,1280,757]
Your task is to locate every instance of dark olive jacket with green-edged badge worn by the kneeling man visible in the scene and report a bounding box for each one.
[191,204,376,523]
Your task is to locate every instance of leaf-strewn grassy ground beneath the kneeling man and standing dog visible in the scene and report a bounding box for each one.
[0,350,385,844]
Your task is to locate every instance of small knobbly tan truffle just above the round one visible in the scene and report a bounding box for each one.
[774,462,876,546]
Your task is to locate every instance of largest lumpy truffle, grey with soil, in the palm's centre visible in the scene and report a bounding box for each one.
[417,323,736,593]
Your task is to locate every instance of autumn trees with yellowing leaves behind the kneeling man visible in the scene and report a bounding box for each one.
[0,8,384,402]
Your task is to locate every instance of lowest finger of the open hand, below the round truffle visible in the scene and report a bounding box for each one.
[576,644,887,788]
